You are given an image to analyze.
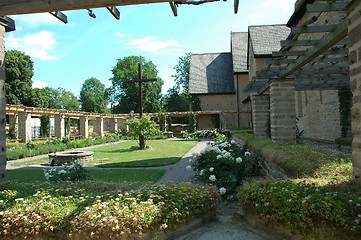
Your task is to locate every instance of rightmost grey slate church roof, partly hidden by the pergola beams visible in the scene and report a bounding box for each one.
[248,25,290,55]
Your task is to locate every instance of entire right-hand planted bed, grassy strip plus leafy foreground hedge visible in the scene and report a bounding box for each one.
[233,131,361,239]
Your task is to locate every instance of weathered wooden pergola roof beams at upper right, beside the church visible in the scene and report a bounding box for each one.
[245,0,351,94]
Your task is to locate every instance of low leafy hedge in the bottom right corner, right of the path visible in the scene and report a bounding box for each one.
[239,180,361,237]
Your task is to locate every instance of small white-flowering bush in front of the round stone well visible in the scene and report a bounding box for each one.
[44,161,89,182]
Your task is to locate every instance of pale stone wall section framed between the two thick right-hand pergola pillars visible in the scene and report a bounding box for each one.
[296,90,341,141]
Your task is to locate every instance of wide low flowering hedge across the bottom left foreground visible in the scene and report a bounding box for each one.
[0,181,219,239]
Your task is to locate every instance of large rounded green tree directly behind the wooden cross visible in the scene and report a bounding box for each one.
[109,56,163,113]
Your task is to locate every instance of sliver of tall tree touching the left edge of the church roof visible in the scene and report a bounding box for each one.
[172,53,192,93]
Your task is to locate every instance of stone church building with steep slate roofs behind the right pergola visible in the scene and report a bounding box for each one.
[189,22,341,141]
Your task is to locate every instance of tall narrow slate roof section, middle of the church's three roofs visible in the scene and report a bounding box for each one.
[231,32,248,73]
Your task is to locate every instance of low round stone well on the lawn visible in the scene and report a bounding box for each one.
[48,151,93,166]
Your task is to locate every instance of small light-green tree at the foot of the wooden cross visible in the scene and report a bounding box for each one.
[124,116,159,149]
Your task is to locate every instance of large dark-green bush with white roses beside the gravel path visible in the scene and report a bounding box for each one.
[191,132,260,198]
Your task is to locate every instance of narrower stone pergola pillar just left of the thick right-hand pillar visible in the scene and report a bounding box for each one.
[252,94,270,138]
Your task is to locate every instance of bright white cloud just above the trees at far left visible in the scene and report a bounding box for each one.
[5,31,57,60]
